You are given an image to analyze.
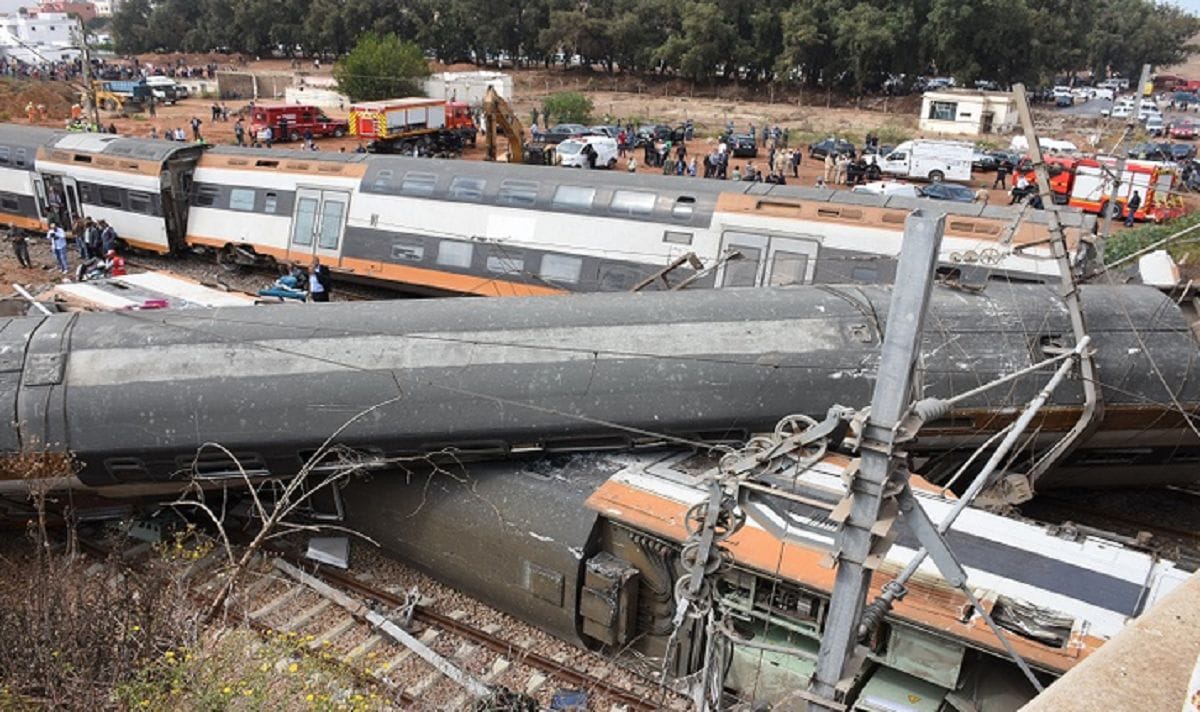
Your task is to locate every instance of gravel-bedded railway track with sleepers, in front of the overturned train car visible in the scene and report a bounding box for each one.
[75,533,685,712]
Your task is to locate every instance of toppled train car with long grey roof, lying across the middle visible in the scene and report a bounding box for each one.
[0,283,1200,489]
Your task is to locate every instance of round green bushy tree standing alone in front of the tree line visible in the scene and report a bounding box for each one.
[334,32,430,101]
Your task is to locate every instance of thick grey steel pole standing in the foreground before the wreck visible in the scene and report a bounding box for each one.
[808,210,946,712]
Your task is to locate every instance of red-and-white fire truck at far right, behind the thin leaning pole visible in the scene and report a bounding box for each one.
[1068,156,1187,222]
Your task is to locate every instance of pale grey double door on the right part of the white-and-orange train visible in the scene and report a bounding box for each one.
[716,231,821,287]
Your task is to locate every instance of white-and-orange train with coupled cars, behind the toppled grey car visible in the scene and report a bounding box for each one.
[0,125,1094,295]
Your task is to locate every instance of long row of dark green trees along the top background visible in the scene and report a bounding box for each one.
[113,0,1200,91]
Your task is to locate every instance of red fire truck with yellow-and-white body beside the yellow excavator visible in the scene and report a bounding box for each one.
[350,97,479,156]
